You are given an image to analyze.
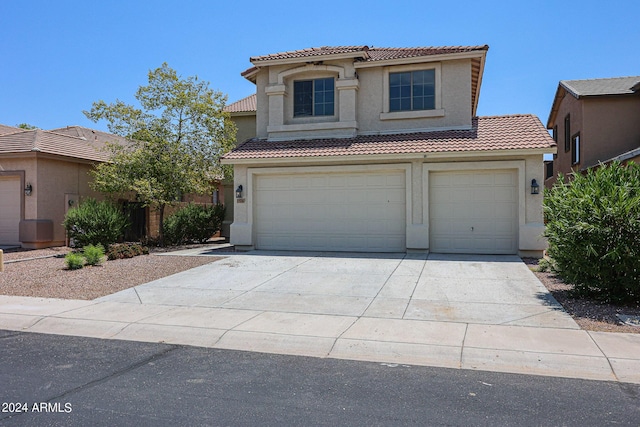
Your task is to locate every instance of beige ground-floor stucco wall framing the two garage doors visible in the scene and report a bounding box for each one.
[231,154,547,256]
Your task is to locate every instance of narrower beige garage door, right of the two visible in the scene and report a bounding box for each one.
[429,170,518,254]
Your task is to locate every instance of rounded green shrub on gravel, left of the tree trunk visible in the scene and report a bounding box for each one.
[63,199,128,248]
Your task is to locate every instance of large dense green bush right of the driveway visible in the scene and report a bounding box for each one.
[543,162,640,303]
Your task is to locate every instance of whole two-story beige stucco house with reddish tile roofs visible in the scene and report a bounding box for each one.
[223,45,556,256]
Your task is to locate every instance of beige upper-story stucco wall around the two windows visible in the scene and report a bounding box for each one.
[256,59,472,140]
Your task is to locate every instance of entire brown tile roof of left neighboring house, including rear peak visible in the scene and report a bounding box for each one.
[0,126,129,161]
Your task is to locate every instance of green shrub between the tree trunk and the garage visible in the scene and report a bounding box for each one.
[164,203,225,245]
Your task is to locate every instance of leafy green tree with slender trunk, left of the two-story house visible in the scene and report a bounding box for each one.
[84,63,236,242]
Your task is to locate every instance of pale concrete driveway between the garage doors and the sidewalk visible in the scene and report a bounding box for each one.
[102,252,578,329]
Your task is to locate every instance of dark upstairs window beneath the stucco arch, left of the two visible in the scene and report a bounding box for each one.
[293,77,334,117]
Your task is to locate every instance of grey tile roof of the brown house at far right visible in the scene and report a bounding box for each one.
[547,76,640,129]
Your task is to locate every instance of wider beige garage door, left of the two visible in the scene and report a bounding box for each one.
[254,171,406,252]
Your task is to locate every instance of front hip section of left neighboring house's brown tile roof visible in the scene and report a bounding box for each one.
[0,129,108,161]
